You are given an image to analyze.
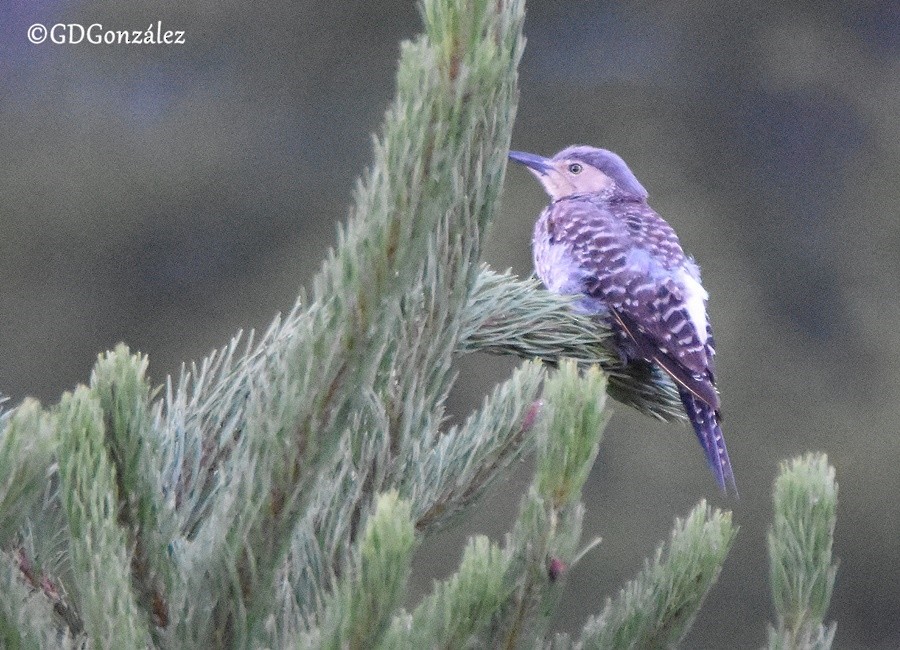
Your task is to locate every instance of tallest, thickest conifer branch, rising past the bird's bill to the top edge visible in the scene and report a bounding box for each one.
[164,0,522,644]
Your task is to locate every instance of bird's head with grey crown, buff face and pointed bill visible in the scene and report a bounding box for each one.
[509,145,647,201]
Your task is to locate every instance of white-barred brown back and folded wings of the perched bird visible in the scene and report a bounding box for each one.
[557,202,719,410]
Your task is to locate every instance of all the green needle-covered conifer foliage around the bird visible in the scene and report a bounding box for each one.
[0,0,834,648]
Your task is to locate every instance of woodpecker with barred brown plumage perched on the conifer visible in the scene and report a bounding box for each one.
[509,145,737,495]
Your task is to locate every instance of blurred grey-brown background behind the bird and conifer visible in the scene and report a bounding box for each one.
[0,0,900,648]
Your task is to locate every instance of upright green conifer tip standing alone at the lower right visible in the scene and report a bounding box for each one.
[769,454,838,649]
